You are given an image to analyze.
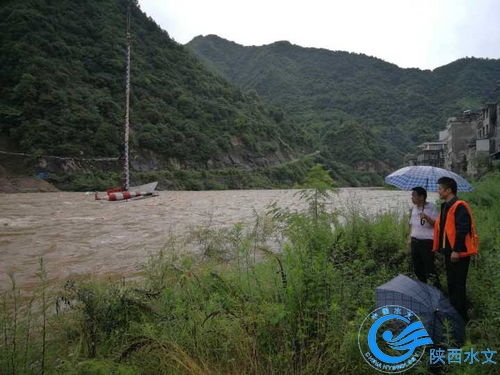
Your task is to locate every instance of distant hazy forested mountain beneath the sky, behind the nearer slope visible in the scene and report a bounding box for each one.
[187,35,500,169]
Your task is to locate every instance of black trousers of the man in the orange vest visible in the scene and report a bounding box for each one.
[444,255,470,321]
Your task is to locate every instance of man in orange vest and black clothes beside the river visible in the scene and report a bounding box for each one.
[433,177,479,321]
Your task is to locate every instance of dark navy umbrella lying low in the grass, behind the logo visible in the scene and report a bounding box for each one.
[376,274,465,345]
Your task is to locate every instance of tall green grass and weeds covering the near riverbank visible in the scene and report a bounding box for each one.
[0,175,500,374]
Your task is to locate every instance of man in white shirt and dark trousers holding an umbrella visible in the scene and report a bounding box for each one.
[409,186,440,288]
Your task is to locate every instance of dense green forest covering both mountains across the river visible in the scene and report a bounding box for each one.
[0,0,500,190]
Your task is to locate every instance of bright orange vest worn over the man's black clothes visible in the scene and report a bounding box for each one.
[432,200,479,258]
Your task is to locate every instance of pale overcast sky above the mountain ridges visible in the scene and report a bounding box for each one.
[139,0,500,69]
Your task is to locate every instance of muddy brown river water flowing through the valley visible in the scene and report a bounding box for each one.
[0,188,436,290]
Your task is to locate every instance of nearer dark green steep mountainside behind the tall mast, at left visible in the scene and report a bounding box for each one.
[0,0,305,187]
